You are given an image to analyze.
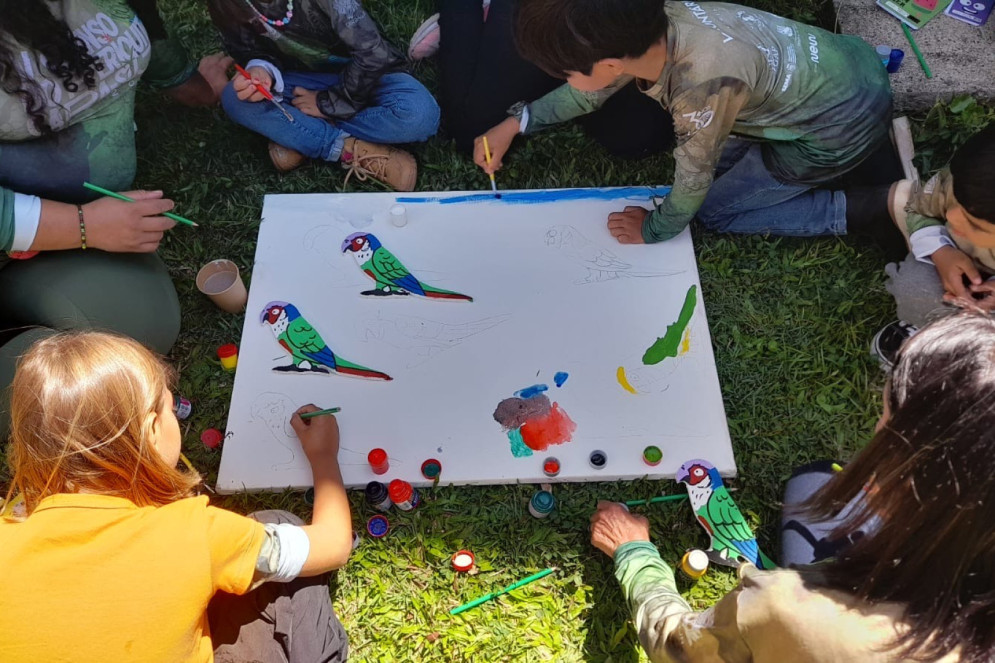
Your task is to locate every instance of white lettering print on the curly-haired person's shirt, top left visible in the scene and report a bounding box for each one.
[20,12,152,131]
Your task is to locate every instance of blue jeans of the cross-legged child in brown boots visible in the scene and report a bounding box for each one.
[221,72,439,161]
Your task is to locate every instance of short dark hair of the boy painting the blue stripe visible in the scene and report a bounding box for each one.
[514,0,668,78]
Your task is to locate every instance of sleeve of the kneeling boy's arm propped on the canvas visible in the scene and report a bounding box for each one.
[642,78,750,243]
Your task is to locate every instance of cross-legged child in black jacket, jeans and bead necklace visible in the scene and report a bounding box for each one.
[208,0,439,191]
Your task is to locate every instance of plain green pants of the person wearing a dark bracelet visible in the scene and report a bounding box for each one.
[0,249,180,440]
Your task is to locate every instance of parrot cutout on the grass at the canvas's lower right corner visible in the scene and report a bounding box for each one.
[674,459,775,569]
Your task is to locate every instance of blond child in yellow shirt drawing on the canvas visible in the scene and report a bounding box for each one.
[0,332,351,663]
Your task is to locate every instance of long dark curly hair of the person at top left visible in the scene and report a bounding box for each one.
[0,0,104,135]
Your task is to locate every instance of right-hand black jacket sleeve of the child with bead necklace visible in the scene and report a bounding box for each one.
[318,0,404,120]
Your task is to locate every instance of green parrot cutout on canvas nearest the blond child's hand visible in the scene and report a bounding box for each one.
[259,302,393,380]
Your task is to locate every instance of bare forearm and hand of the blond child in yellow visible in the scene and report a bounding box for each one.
[290,405,352,576]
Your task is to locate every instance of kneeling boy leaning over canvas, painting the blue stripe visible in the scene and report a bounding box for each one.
[474,0,899,249]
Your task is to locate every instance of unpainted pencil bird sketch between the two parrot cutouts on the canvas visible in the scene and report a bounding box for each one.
[356,311,512,368]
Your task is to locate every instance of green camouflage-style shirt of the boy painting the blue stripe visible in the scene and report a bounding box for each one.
[526,2,891,241]
